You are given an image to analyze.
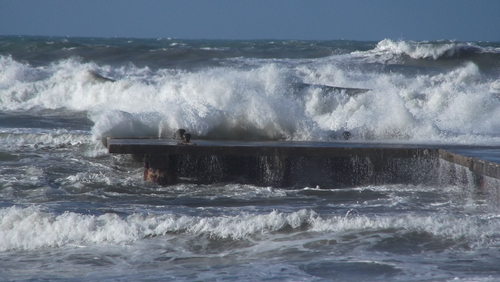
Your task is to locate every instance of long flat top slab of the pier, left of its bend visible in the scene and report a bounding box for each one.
[108,138,438,158]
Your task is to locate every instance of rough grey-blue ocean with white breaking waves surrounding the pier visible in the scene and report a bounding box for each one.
[0,36,500,281]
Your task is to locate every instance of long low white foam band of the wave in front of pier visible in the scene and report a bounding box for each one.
[0,206,500,251]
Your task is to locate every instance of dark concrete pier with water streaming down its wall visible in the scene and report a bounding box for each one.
[107,138,500,188]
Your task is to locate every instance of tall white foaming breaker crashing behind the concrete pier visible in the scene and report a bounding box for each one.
[0,53,500,144]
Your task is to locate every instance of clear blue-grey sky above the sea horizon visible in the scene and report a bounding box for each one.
[0,0,500,42]
